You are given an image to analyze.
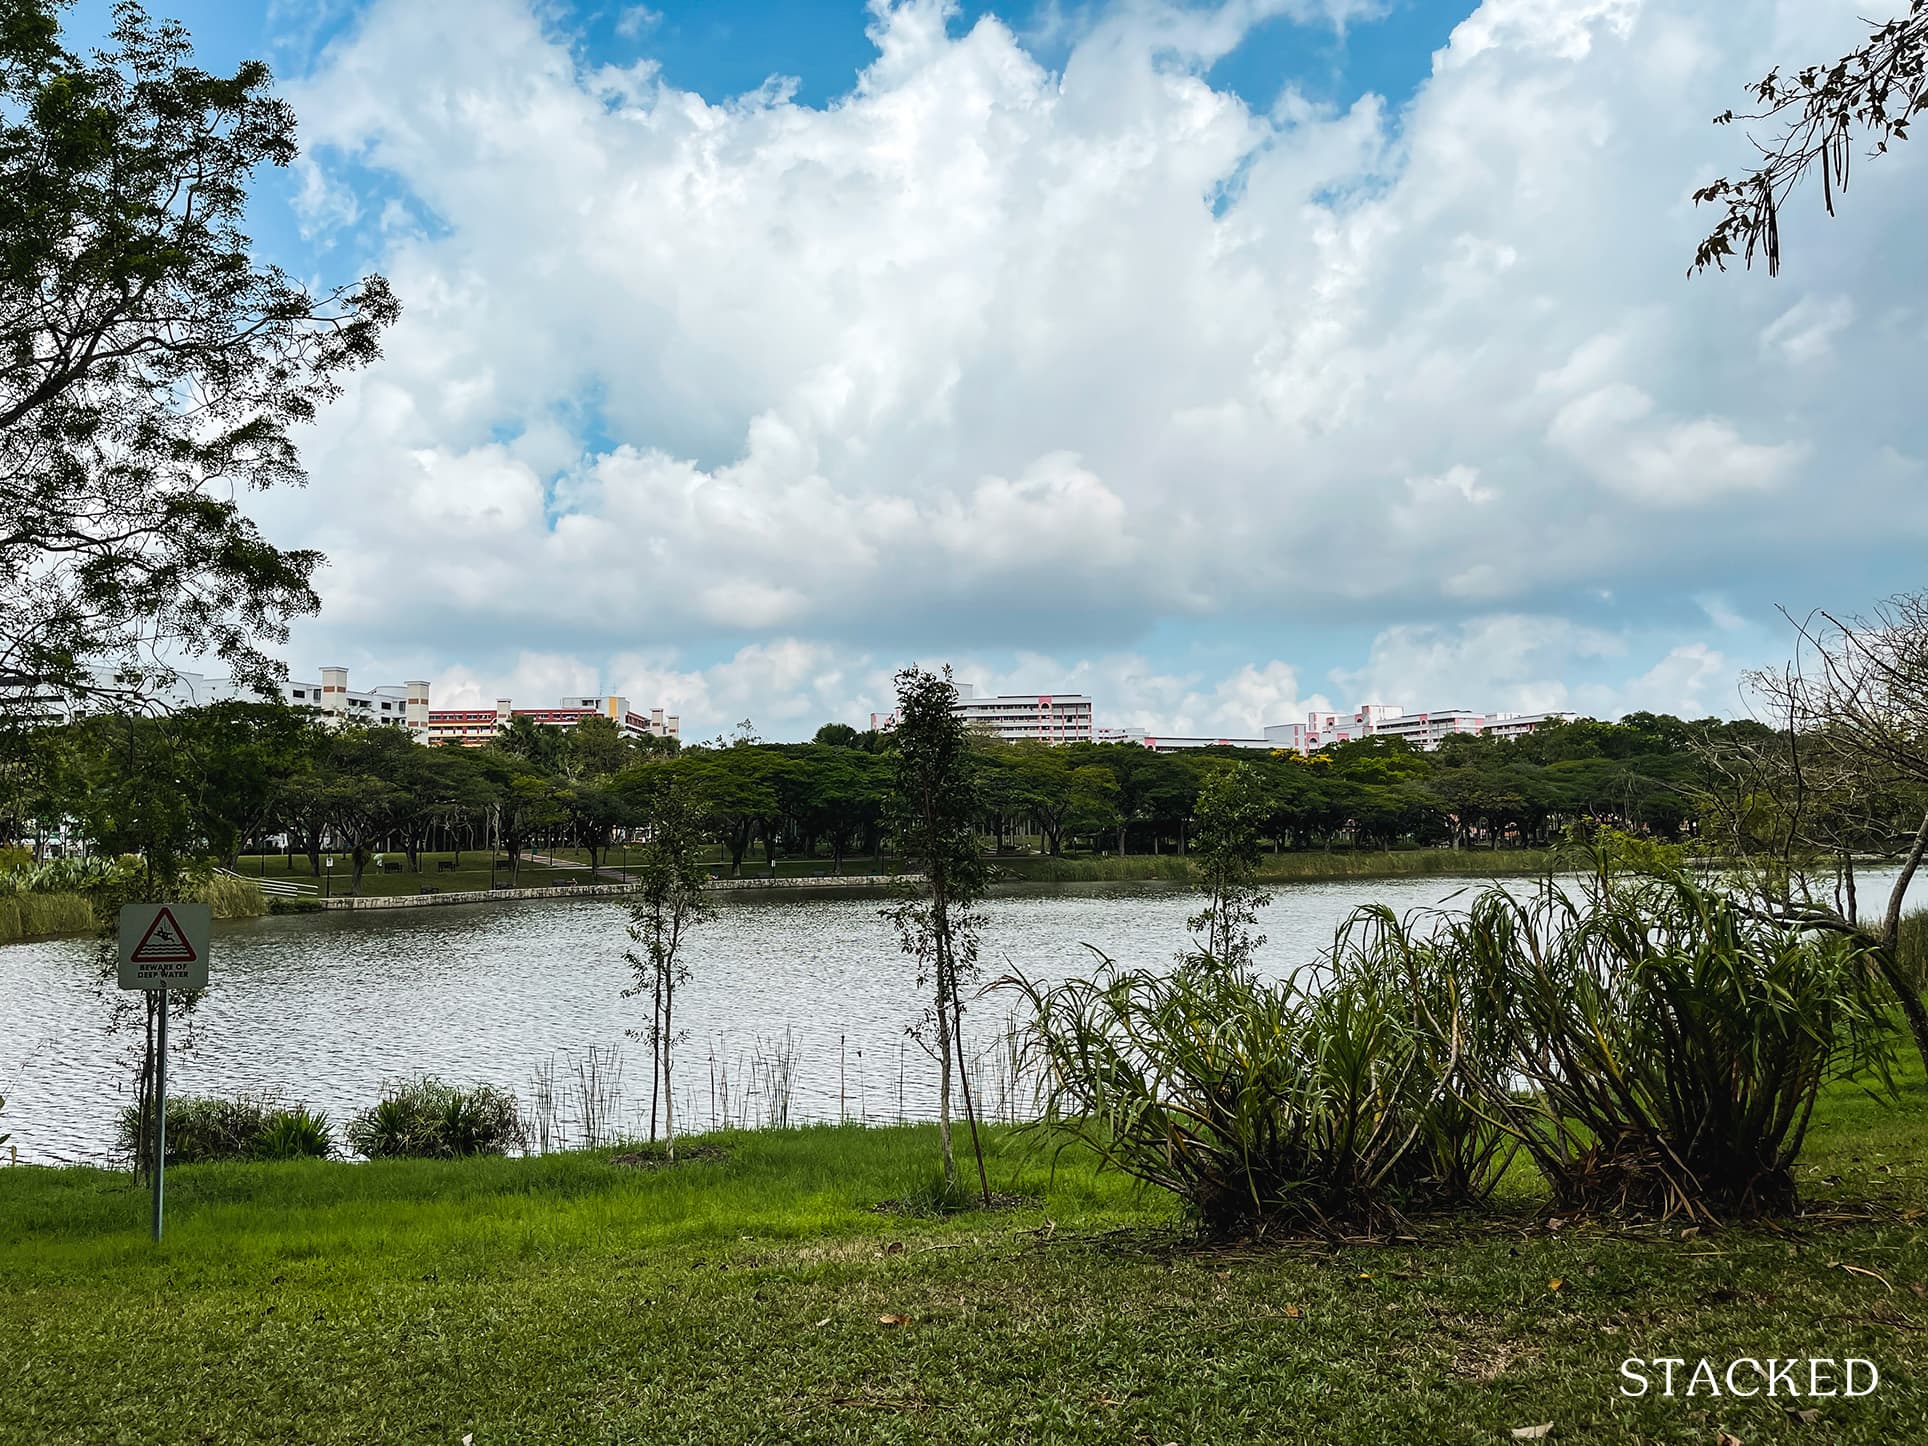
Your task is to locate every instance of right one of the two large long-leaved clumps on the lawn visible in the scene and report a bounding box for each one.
[1434,860,1891,1218]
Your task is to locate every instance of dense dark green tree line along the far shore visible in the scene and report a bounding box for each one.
[0,704,1804,887]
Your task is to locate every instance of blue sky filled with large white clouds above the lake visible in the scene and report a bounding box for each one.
[77,0,1928,738]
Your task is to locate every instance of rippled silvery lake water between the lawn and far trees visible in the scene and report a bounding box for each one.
[0,875,1912,1163]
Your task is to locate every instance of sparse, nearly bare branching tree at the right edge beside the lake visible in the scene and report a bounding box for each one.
[1704,592,1928,1064]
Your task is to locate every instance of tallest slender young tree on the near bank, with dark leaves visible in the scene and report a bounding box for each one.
[883,667,991,1207]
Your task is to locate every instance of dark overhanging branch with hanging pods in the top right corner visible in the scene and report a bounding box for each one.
[1693,0,1928,276]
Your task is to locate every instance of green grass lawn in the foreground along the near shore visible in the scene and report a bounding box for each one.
[11,1078,1928,1446]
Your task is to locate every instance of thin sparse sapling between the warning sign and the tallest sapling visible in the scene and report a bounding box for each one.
[623,773,715,1163]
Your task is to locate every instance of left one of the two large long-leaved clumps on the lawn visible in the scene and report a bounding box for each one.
[1008,956,1431,1234]
